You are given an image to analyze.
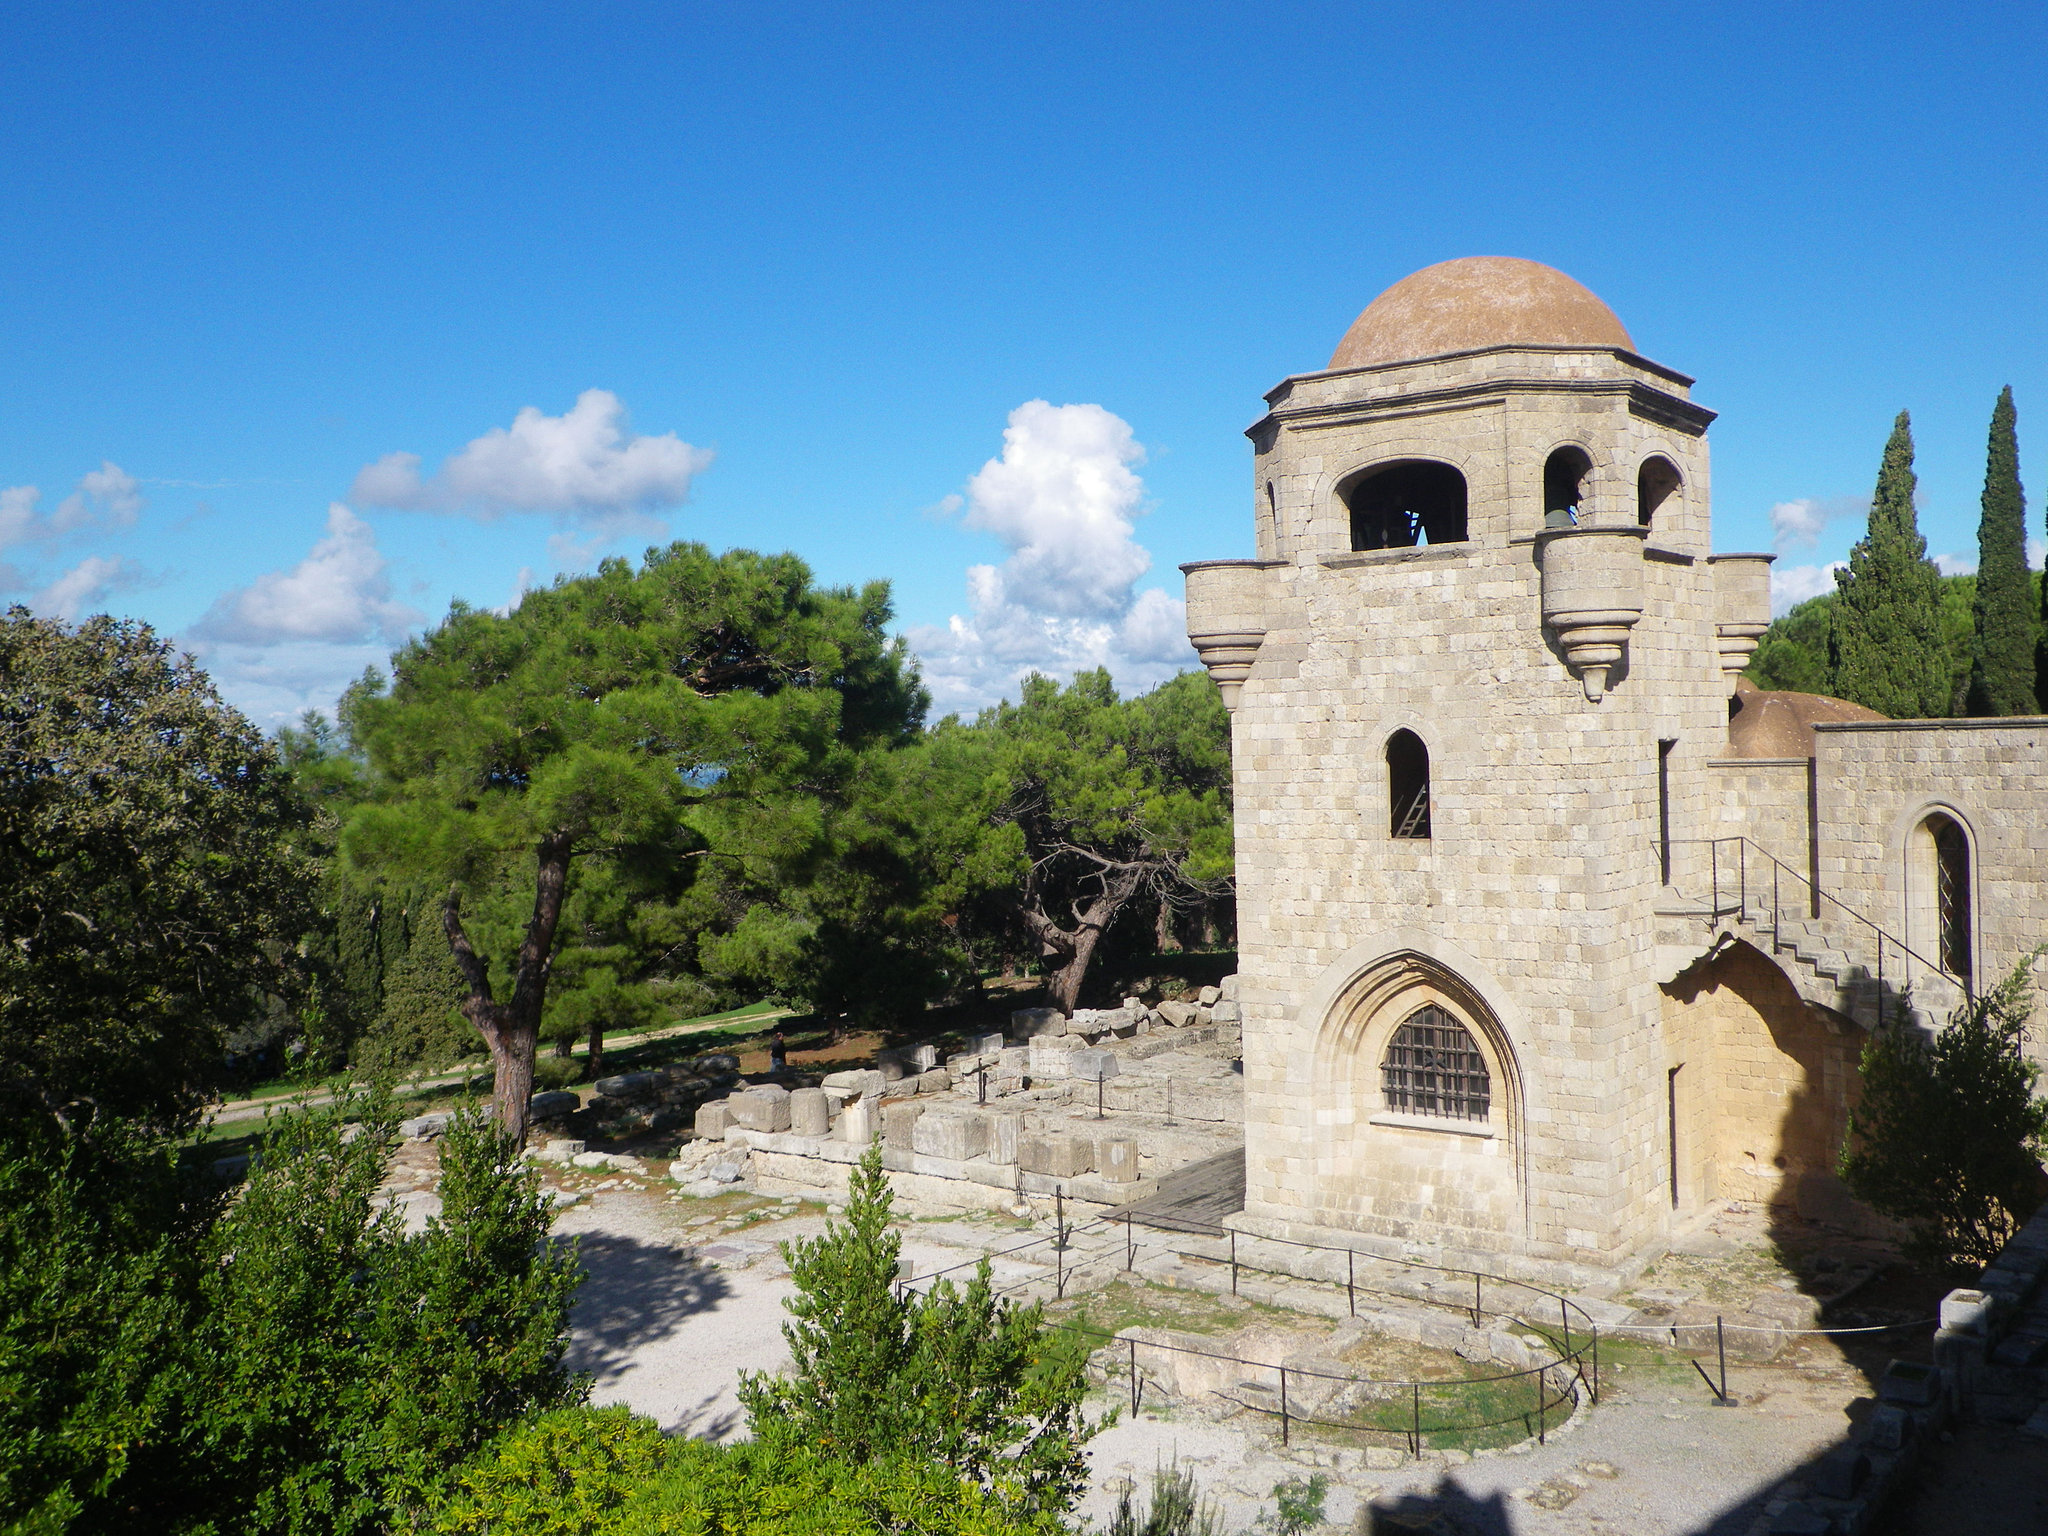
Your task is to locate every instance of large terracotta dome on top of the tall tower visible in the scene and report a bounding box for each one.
[1329,256,1636,369]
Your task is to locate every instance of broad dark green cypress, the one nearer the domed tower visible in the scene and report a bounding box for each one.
[1829,412,1952,719]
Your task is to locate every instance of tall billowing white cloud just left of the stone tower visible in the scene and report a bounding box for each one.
[909,399,1196,713]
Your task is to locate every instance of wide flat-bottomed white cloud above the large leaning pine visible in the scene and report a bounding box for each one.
[350,389,711,524]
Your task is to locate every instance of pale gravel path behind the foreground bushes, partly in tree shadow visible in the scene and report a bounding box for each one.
[557,1188,1900,1536]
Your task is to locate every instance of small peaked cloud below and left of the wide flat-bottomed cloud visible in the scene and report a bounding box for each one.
[190,502,424,645]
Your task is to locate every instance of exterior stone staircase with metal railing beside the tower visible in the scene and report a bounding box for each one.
[1657,838,1968,1030]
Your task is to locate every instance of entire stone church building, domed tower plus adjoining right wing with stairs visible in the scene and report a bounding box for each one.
[1184,258,2048,1276]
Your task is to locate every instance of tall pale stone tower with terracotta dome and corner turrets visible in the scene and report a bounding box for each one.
[1184,256,1769,1276]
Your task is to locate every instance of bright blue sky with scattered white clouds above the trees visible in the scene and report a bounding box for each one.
[0,4,2048,725]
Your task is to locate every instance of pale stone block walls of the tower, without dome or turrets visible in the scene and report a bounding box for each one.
[1233,350,1729,1266]
